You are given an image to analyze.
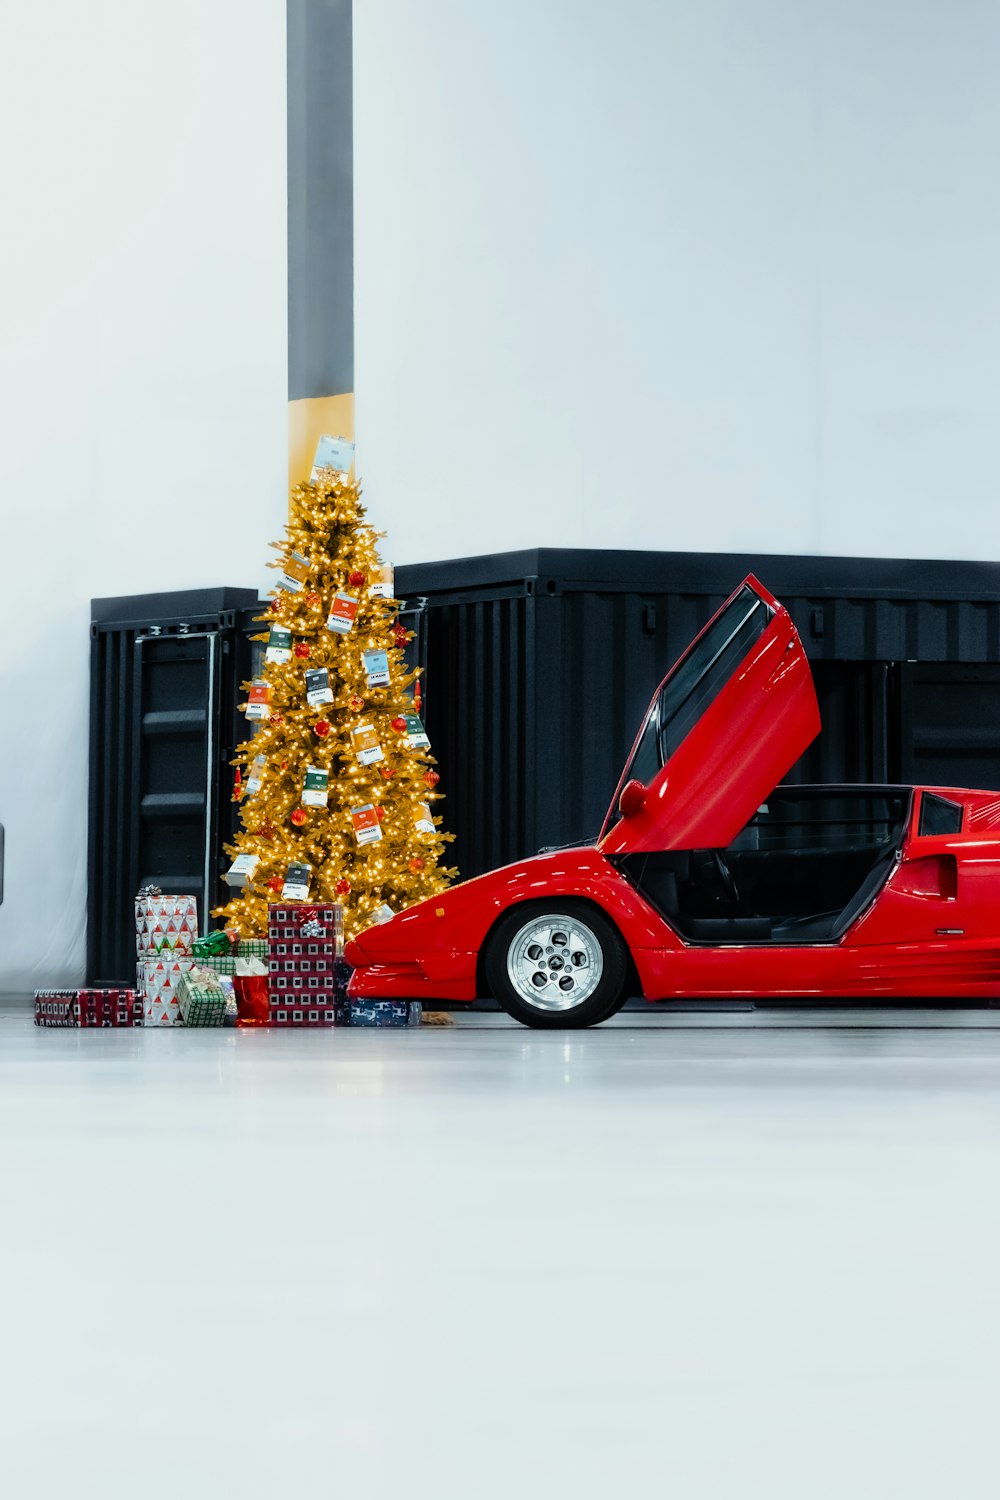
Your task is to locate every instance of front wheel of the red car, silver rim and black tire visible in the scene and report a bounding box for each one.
[486,897,628,1031]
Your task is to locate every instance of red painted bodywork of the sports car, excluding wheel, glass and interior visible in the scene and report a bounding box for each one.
[346,579,1000,1001]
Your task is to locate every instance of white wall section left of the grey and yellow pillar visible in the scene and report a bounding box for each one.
[0,0,288,992]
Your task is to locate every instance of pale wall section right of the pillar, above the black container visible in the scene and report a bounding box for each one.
[354,0,1000,561]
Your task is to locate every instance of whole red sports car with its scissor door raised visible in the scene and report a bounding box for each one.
[346,578,1000,1026]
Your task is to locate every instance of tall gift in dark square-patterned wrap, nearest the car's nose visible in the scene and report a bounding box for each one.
[267,902,343,1026]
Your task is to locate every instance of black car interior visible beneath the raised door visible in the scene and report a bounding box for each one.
[618,786,912,947]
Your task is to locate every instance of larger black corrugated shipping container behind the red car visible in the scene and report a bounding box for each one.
[396,549,1000,878]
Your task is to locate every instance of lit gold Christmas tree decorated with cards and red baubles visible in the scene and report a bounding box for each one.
[216,468,456,938]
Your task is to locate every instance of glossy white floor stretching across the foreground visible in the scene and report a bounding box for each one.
[0,1011,1000,1500]
